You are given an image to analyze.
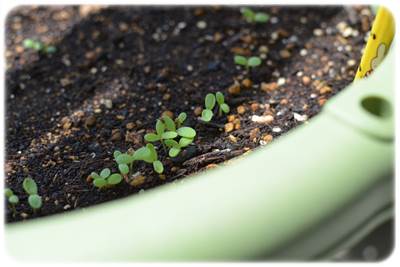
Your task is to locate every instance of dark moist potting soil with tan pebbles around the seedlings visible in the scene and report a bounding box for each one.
[5,6,372,222]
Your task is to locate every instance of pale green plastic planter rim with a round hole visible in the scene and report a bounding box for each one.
[5,41,394,261]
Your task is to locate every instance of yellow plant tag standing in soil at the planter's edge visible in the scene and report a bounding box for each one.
[354,6,394,80]
